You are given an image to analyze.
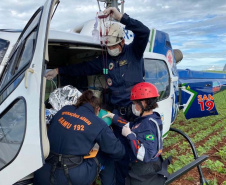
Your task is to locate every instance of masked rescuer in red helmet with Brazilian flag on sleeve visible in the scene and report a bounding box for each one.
[103,82,168,185]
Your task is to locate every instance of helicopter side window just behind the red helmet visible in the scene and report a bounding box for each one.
[144,59,170,101]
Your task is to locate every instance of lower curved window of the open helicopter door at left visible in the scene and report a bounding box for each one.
[0,99,26,171]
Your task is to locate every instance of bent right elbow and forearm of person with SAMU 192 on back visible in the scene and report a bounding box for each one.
[96,126,125,160]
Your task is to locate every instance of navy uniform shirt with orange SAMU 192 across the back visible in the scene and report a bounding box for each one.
[48,103,125,160]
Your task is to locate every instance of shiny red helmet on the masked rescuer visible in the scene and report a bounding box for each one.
[130,82,159,100]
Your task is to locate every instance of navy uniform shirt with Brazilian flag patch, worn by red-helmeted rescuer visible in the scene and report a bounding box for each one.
[113,112,162,162]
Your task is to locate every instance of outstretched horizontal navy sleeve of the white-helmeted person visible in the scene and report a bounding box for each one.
[58,57,103,76]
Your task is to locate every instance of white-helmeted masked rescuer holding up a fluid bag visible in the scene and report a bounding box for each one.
[46,8,150,185]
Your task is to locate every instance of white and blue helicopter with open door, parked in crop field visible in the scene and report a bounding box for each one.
[0,0,226,185]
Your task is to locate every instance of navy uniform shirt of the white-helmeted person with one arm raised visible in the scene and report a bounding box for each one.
[59,14,150,106]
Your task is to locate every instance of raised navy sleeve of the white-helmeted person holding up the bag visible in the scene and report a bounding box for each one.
[120,14,150,59]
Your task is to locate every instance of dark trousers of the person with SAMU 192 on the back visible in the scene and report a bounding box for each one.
[34,151,115,185]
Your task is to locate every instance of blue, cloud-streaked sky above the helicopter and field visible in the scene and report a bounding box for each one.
[0,0,226,70]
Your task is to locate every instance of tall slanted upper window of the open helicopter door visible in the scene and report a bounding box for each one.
[0,10,42,102]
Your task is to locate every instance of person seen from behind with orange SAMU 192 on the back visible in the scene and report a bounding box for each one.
[34,90,125,185]
